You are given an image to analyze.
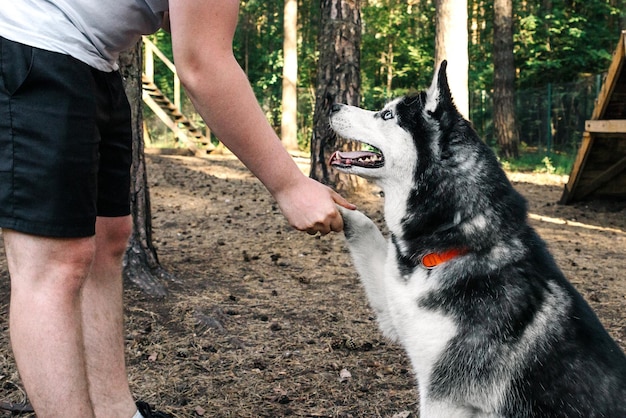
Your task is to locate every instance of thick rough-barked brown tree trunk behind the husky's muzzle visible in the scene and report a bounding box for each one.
[310,0,361,190]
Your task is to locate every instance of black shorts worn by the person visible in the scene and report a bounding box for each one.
[0,37,132,237]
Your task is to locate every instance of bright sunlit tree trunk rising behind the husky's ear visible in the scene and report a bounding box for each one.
[435,0,469,118]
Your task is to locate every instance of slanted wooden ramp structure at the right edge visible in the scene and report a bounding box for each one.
[561,31,626,204]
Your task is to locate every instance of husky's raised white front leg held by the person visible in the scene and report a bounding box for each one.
[340,208,397,340]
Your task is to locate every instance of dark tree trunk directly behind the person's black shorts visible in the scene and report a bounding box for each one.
[120,42,171,296]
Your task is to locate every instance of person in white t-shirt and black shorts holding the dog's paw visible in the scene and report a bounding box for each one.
[0,0,354,418]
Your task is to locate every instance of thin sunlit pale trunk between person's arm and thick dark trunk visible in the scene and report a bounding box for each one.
[280,0,298,151]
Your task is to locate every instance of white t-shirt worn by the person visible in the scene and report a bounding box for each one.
[0,0,168,71]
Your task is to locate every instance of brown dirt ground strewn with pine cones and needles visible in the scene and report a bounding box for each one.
[0,155,626,418]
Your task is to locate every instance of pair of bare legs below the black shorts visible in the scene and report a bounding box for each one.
[3,217,137,418]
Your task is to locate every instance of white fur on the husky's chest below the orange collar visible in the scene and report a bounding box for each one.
[385,244,457,380]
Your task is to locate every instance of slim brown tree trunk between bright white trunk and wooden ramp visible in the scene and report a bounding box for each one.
[493,0,519,159]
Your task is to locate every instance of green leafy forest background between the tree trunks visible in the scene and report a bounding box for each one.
[145,0,626,174]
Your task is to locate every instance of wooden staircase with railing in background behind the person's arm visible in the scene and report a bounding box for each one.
[141,38,215,156]
